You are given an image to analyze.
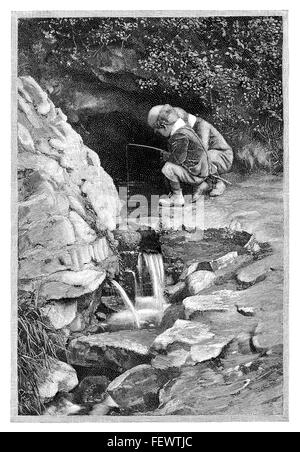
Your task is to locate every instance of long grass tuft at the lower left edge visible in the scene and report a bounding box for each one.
[18,298,63,416]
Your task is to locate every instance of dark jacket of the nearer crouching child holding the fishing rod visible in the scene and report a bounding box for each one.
[168,126,209,177]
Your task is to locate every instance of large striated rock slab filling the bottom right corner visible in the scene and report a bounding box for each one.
[155,356,283,420]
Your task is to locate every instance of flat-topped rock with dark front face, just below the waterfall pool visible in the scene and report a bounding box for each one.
[68,330,156,372]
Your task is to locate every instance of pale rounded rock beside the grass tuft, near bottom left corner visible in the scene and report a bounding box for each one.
[38,360,78,400]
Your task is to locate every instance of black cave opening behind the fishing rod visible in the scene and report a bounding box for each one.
[75,112,167,191]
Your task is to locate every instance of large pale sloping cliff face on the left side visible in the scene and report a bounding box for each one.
[18,77,120,318]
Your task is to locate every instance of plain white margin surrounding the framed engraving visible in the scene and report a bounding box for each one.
[0,0,300,432]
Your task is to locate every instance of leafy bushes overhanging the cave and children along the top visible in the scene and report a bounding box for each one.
[19,16,283,170]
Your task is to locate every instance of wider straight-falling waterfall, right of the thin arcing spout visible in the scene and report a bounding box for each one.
[143,253,165,312]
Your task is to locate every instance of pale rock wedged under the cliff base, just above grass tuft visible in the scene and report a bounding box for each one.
[41,301,77,330]
